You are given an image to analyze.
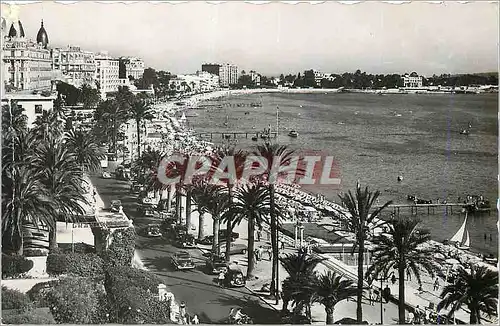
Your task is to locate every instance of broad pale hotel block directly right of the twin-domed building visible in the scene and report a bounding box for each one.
[52,46,97,88]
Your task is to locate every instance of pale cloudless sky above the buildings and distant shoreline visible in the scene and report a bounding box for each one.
[2,1,499,76]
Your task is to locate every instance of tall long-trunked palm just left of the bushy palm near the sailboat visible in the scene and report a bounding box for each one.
[339,182,392,323]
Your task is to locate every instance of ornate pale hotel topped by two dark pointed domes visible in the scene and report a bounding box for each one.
[1,20,54,92]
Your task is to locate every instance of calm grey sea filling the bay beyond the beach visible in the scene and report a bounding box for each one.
[186,93,498,256]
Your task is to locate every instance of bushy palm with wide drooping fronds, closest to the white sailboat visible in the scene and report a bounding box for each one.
[366,219,436,324]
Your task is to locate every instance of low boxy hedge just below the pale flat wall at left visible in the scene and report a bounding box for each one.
[47,251,104,277]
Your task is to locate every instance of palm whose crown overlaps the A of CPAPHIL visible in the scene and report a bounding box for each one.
[212,147,248,261]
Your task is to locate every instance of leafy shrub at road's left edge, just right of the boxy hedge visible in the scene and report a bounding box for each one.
[103,227,136,266]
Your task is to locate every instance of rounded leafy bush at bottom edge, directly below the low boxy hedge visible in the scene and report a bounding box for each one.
[47,278,104,324]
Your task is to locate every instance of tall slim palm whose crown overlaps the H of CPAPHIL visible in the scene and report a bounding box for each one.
[255,142,294,297]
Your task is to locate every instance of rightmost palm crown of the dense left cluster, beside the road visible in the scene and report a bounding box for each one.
[65,130,104,171]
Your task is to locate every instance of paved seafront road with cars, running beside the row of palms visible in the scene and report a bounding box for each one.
[91,177,279,324]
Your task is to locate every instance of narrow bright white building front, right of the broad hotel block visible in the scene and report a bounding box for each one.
[95,53,123,98]
